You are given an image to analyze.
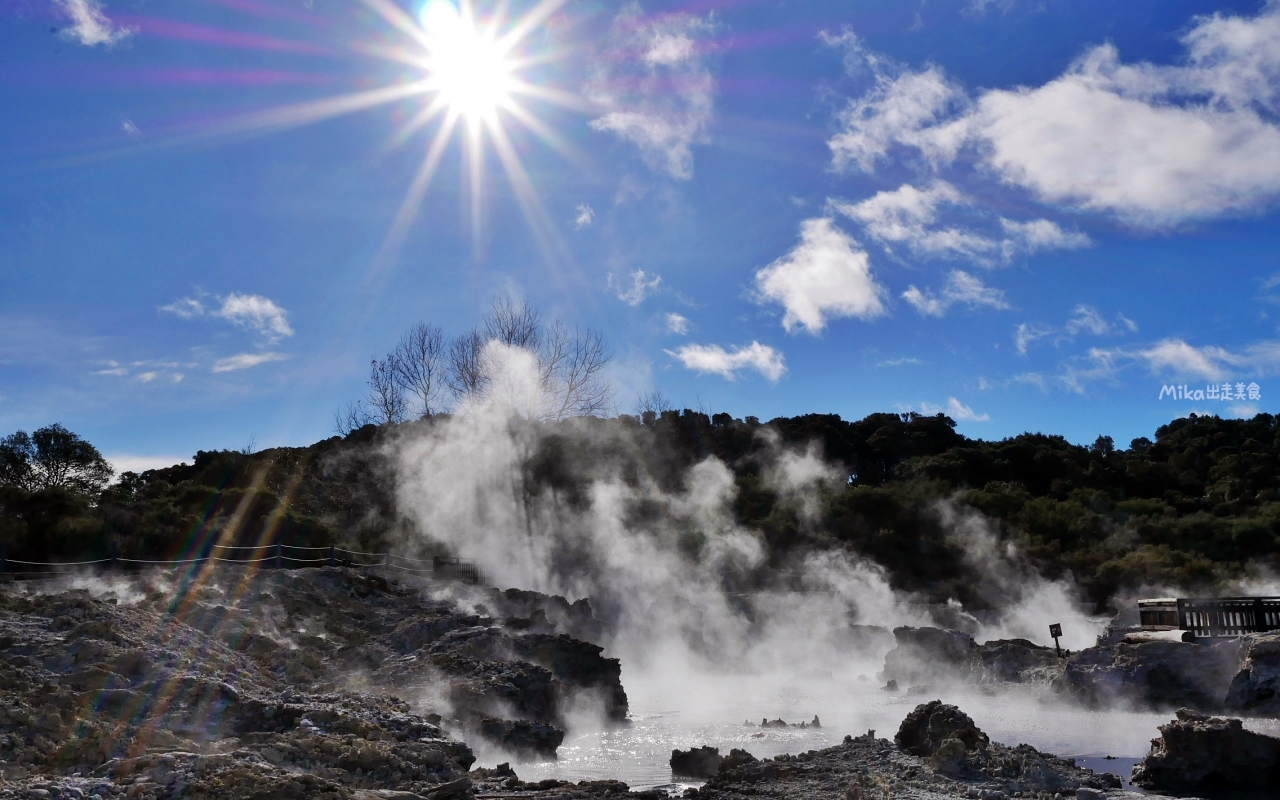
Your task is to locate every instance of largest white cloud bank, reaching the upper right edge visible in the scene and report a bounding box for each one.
[829,3,1280,227]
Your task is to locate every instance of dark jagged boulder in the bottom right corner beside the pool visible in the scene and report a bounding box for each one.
[1133,708,1280,792]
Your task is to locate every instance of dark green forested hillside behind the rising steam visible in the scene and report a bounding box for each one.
[0,410,1280,608]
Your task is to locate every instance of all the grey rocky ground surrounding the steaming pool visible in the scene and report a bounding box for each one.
[10,567,1280,800]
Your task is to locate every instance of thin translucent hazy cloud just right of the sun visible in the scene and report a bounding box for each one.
[584,3,716,179]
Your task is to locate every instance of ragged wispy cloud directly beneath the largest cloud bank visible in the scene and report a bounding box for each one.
[828,180,1089,266]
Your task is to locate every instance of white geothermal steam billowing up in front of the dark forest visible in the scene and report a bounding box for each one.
[394,342,1100,675]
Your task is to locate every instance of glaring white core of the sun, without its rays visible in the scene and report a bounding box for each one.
[419,0,516,124]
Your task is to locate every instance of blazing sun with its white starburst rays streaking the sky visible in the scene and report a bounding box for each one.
[20,0,590,277]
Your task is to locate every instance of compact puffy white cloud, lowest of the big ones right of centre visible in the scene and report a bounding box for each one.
[755,216,884,334]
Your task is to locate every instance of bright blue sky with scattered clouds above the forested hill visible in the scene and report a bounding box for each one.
[0,0,1280,467]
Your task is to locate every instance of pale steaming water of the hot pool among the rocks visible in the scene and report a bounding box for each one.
[479,676,1280,790]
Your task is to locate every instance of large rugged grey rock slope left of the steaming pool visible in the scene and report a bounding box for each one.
[0,567,627,800]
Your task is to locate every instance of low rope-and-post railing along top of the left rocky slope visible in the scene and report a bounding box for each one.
[0,544,484,584]
